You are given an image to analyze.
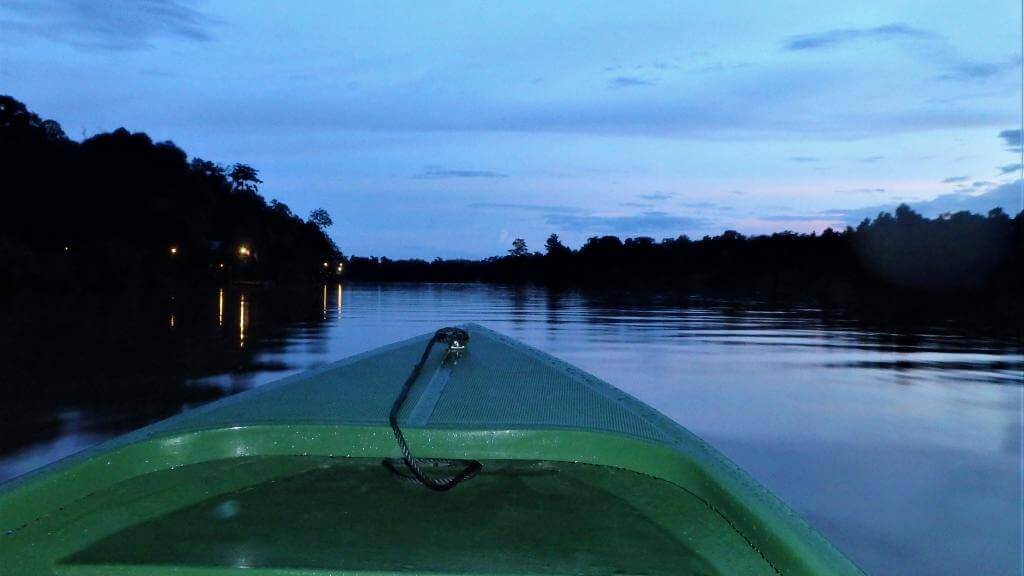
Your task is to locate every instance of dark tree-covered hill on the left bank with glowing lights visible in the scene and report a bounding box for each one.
[0,96,341,292]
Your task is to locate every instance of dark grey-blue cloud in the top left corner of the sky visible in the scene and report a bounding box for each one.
[0,0,218,51]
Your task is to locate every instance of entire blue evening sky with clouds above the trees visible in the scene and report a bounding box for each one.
[0,0,1024,258]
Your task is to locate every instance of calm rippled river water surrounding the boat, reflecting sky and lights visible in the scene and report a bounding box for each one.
[0,284,1024,574]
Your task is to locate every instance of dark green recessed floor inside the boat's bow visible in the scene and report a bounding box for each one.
[33,457,775,576]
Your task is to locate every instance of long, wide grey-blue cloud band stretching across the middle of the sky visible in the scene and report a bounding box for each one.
[172,60,1013,142]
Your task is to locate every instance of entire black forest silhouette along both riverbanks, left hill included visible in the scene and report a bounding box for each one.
[0,96,1024,321]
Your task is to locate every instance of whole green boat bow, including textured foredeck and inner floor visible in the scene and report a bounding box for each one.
[0,325,861,575]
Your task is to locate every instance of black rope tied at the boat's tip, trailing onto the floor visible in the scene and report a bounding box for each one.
[384,328,483,492]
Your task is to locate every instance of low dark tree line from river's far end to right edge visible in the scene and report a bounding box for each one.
[347,204,1024,319]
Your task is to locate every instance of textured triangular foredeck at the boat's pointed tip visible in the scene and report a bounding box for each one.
[138,325,682,443]
